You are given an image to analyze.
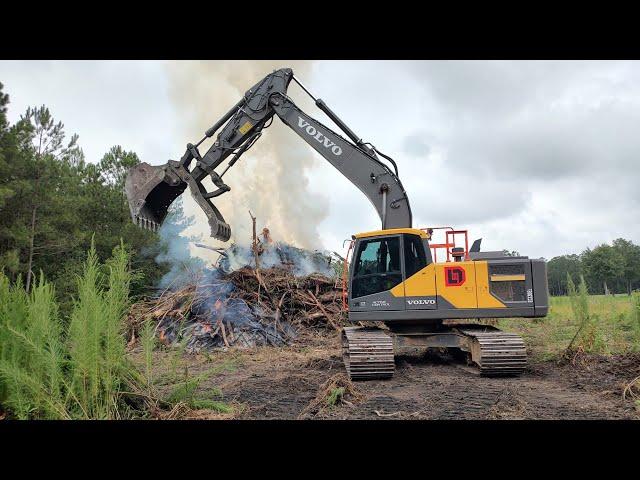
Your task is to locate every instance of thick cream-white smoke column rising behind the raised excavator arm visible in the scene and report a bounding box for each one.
[167,60,328,260]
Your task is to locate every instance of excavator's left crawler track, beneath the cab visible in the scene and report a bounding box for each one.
[342,327,395,380]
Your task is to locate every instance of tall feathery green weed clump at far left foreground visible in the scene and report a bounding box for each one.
[0,244,139,419]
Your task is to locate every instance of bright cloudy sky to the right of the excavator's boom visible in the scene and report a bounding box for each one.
[304,61,640,257]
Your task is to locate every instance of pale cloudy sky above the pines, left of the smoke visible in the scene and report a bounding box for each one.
[0,60,178,164]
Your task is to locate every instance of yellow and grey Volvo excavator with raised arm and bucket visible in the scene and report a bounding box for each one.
[125,68,549,380]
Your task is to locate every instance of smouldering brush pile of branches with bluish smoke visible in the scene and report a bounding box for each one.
[128,232,343,353]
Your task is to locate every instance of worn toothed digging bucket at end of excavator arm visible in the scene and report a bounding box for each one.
[125,163,187,232]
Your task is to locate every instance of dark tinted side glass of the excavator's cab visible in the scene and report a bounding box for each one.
[351,237,402,298]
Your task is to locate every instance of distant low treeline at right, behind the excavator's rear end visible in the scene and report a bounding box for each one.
[547,238,640,295]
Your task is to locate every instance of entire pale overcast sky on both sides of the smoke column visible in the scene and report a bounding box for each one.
[0,61,640,258]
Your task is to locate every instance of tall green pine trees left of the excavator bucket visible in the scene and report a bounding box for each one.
[0,83,166,308]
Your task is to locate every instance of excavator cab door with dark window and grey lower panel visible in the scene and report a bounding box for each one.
[349,235,404,312]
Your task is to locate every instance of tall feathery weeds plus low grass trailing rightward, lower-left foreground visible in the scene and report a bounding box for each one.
[0,240,233,419]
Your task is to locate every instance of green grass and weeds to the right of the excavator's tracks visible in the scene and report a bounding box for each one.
[497,292,640,359]
